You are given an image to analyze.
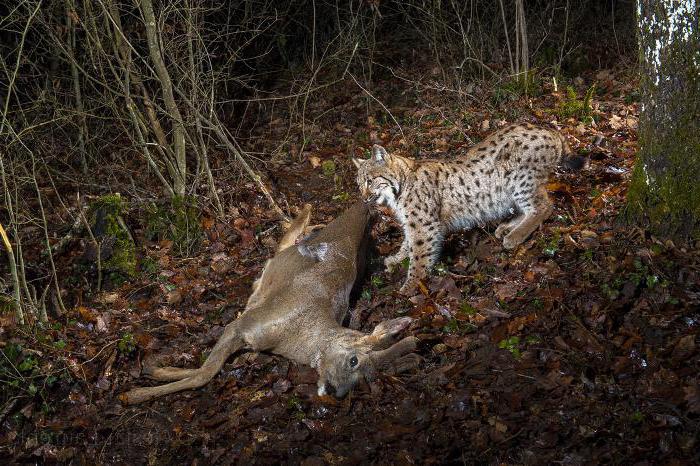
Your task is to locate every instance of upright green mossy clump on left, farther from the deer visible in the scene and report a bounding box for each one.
[90,194,136,282]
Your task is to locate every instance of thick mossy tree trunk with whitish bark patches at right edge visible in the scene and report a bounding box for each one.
[627,0,700,239]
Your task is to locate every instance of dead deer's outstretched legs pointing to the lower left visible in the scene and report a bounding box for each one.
[119,323,244,404]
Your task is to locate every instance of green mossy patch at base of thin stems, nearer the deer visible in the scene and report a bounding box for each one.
[146,196,203,257]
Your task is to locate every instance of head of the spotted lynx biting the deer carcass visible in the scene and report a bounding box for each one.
[352,144,413,207]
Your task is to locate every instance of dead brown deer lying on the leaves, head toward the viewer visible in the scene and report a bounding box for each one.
[120,202,417,404]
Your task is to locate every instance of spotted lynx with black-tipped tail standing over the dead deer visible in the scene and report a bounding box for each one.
[353,124,584,293]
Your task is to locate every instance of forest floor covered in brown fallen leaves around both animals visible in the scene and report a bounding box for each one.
[0,63,700,465]
